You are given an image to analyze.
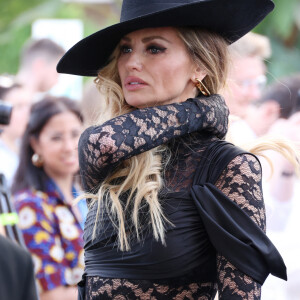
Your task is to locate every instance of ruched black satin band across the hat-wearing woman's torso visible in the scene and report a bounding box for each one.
[85,192,216,281]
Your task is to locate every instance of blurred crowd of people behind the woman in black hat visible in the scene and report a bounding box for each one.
[0,0,300,300]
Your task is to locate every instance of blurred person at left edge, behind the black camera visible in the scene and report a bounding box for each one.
[0,82,33,187]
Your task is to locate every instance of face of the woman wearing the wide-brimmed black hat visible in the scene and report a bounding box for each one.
[118,27,204,108]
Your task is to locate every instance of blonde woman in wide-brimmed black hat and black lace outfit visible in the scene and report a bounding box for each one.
[57,0,286,299]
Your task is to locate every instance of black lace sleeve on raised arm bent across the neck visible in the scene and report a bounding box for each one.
[79,95,228,190]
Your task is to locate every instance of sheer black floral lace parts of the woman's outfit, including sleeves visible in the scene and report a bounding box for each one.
[79,95,265,300]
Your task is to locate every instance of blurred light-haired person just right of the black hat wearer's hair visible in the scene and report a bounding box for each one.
[224,32,271,118]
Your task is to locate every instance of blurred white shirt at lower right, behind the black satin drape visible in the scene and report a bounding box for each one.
[262,180,300,300]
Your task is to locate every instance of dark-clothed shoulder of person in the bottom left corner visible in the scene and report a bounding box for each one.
[0,233,38,300]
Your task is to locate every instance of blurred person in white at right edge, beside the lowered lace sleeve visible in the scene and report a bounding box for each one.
[262,112,300,300]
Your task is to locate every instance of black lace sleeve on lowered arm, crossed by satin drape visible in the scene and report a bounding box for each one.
[216,154,266,300]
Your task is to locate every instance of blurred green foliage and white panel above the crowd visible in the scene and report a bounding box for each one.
[0,0,300,99]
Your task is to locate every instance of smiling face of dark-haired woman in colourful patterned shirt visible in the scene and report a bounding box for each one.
[31,112,82,179]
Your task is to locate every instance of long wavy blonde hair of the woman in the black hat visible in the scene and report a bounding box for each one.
[84,28,228,251]
